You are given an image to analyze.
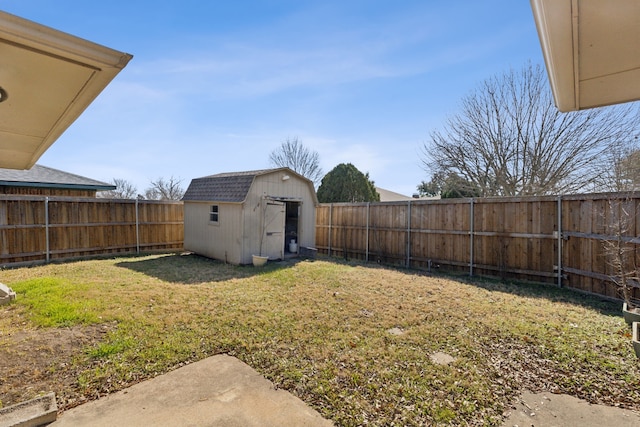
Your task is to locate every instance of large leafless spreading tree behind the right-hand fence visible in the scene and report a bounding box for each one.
[422,64,640,196]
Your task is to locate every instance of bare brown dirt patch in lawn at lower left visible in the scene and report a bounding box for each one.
[0,324,114,407]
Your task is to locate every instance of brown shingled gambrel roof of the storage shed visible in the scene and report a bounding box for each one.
[182,168,317,203]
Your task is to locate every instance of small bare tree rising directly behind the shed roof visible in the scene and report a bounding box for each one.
[269,137,322,185]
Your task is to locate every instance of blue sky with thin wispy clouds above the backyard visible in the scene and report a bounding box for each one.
[0,0,543,195]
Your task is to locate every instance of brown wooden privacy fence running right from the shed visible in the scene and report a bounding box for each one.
[316,193,640,298]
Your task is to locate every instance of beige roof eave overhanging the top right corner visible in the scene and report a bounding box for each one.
[531,0,640,111]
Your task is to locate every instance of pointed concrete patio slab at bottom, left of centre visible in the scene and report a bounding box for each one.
[50,355,333,427]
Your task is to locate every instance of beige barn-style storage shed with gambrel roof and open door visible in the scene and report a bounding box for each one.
[182,168,318,264]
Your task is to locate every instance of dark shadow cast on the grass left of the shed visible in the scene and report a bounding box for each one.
[116,253,295,285]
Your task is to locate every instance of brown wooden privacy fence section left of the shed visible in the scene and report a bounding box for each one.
[0,196,184,265]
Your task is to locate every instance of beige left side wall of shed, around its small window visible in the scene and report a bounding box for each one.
[184,202,246,264]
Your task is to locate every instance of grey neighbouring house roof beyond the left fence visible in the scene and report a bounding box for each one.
[0,165,116,191]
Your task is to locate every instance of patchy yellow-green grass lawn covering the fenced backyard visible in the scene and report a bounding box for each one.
[0,254,640,426]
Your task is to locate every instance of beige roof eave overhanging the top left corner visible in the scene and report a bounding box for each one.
[0,11,132,169]
